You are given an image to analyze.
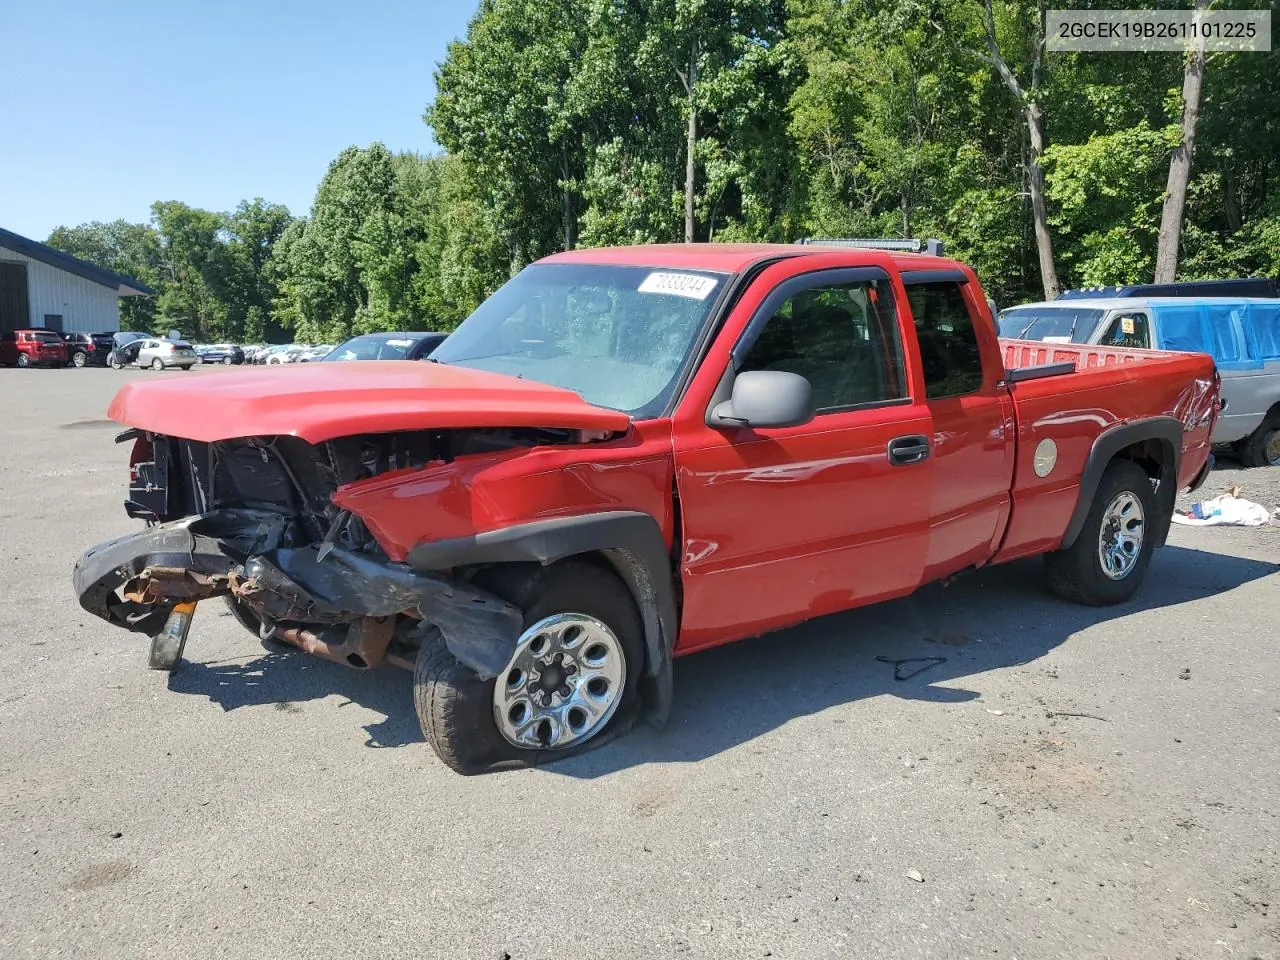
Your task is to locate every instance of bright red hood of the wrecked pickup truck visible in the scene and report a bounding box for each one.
[106,360,631,443]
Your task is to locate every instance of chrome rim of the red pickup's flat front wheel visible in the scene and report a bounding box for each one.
[493,613,627,750]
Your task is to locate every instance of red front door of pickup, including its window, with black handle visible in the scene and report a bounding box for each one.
[673,264,933,650]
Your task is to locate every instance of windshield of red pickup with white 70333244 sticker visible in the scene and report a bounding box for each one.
[431,264,726,417]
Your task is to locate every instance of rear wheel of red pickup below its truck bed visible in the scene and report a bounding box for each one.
[1044,460,1158,607]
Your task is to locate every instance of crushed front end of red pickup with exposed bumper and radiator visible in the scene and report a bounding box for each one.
[73,430,583,678]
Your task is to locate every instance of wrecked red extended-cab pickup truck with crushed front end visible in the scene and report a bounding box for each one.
[74,244,1219,773]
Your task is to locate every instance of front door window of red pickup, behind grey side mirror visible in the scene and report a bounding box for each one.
[739,280,906,412]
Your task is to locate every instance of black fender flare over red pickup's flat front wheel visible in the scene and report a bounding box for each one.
[406,511,678,727]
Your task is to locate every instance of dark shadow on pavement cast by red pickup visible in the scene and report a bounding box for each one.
[170,547,1280,778]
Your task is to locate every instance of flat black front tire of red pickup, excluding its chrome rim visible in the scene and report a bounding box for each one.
[413,561,644,774]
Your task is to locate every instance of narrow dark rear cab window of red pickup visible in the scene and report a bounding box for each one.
[906,280,983,399]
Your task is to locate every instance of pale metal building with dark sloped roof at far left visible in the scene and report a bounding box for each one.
[0,229,155,333]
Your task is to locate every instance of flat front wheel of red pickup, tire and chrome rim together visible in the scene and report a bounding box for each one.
[413,561,644,774]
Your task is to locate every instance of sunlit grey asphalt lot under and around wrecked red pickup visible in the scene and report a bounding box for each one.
[0,369,1280,960]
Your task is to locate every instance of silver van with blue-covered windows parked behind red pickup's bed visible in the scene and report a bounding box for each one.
[1000,297,1280,467]
